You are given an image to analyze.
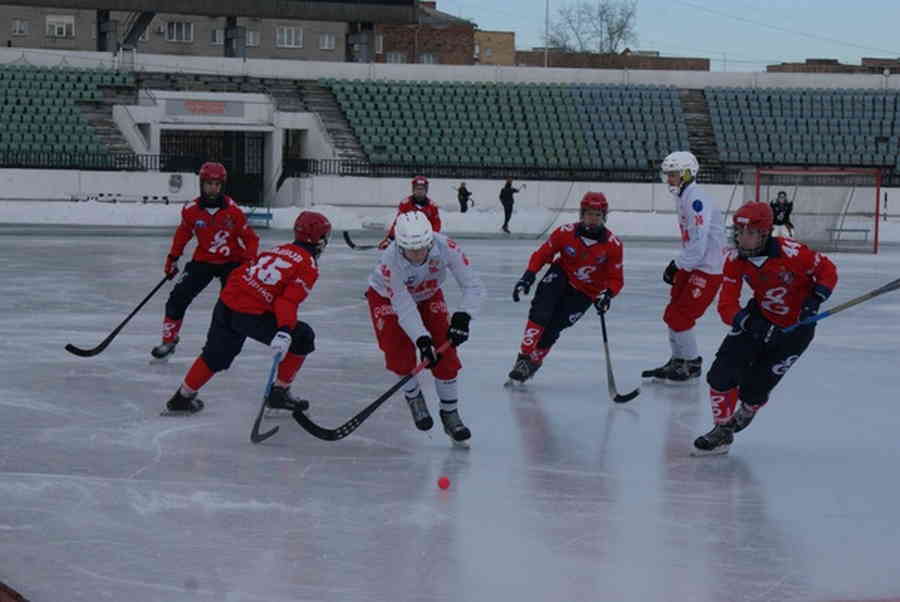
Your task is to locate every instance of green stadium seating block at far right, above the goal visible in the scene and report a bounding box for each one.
[705,88,900,167]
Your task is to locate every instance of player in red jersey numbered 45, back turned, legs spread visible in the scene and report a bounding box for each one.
[165,211,331,414]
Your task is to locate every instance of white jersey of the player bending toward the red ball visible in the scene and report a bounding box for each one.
[369,232,486,341]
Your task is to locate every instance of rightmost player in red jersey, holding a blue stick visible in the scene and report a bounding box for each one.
[693,202,837,455]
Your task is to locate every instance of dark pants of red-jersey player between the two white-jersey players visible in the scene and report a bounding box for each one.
[528,264,591,349]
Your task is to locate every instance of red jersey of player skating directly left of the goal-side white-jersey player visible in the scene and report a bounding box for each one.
[528,223,624,300]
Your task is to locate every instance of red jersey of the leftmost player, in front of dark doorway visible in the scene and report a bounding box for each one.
[169,196,259,263]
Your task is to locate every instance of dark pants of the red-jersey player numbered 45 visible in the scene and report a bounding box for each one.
[201,299,316,372]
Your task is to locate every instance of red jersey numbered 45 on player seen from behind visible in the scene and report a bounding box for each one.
[220,243,319,329]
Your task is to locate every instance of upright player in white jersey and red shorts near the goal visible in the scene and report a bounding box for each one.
[641,151,725,383]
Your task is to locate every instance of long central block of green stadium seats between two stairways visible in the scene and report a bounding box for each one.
[319,79,688,169]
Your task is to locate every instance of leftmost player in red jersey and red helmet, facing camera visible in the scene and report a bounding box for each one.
[150,163,259,360]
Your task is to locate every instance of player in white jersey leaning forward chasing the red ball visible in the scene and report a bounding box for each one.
[366,211,485,443]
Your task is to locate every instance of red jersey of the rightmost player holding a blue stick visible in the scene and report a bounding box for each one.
[719,237,837,328]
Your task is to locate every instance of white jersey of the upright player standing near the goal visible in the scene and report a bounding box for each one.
[674,182,725,274]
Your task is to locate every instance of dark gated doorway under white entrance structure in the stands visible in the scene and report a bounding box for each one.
[160,130,266,206]
